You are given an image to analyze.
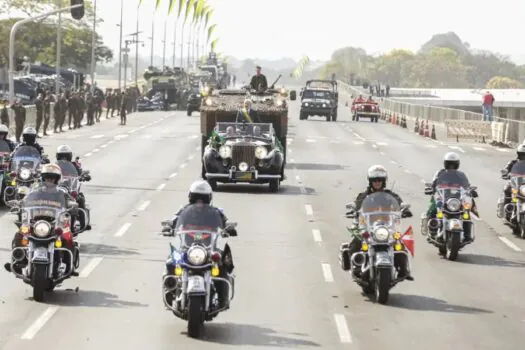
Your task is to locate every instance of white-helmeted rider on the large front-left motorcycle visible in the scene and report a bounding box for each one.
[4,164,78,276]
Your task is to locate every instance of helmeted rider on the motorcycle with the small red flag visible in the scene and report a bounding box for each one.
[340,165,414,281]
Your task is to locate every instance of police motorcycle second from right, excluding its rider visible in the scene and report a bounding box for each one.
[421,170,477,261]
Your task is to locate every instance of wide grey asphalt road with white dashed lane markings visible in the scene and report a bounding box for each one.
[0,102,525,350]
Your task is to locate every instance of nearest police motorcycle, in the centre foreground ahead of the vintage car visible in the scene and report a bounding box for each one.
[162,207,237,338]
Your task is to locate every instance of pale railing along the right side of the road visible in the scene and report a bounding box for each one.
[338,81,525,144]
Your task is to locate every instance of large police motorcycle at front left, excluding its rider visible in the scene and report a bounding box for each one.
[8,190,89,302]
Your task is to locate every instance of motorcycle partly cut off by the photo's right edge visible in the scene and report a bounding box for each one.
[497,161,525,238]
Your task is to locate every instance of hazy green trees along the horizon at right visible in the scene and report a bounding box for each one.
[320,33,525,88]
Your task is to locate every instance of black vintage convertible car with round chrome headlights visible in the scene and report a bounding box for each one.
[202,123,284,192]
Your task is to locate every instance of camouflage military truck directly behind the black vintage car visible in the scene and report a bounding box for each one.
[200,79,294,189]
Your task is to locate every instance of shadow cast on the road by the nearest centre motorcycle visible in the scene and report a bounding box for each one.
[195,323,321,349]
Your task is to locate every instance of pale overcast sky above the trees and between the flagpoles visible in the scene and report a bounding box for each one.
[44,0,525,60]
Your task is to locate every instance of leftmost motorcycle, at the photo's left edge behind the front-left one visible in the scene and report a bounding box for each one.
[4,145,49,203]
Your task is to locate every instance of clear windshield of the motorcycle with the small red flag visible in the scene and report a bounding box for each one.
[359,192,401,231]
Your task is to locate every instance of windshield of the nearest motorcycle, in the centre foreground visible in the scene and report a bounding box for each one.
[175,204,223,247]
